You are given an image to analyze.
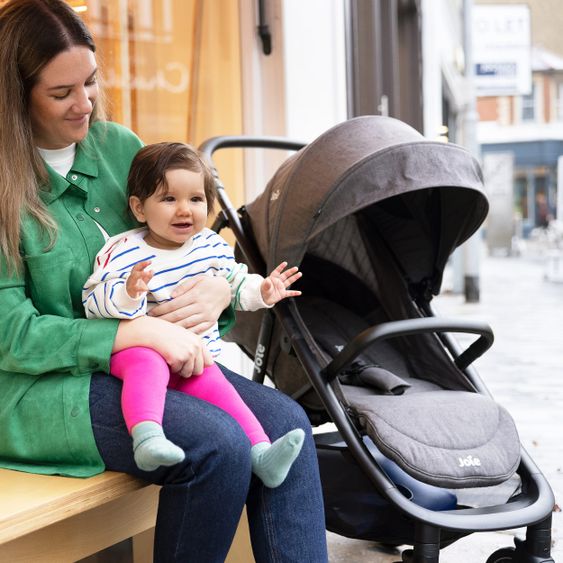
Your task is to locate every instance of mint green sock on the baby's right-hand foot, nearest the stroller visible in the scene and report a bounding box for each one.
[250,428,305,489]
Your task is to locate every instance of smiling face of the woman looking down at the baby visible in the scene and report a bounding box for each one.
[29,46,98,149]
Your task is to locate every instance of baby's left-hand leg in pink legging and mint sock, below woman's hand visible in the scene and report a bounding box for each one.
[110,347,185,471]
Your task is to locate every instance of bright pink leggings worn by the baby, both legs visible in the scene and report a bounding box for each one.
[110,347,270,445]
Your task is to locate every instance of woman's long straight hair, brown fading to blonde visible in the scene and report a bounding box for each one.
[0,0,101,271]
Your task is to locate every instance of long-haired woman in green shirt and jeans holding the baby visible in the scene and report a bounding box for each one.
[0,0,327,563]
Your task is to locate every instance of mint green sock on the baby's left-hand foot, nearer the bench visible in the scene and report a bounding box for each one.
[131,420,185,471]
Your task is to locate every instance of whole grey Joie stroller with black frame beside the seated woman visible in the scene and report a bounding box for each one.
[200,116,554,563]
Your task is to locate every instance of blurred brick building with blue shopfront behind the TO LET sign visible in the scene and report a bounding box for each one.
[477,0,563,236]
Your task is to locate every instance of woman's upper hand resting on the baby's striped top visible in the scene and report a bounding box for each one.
[149,276,231,334]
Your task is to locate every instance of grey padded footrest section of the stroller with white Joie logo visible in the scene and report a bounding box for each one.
[353,391,520,488]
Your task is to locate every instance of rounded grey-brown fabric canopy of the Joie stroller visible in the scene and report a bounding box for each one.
[247,116,488,294]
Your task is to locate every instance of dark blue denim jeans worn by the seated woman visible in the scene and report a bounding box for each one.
[90,367,328,563]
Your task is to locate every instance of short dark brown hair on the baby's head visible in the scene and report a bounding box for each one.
[127,142,215,214]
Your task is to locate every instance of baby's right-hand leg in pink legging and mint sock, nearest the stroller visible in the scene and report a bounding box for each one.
[170,365,305,488]
